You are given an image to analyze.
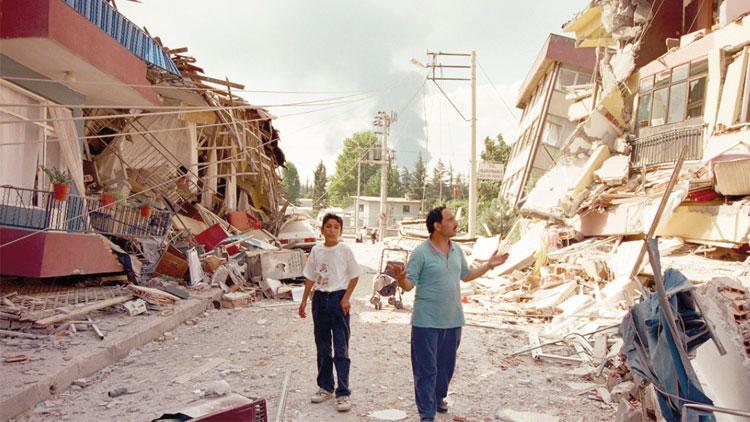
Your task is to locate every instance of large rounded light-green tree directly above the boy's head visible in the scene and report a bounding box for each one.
[328,131,379,207]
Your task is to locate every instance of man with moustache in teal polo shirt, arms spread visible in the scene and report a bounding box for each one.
[394,207,508,421]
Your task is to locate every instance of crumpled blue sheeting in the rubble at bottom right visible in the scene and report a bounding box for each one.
[620,269,715,422]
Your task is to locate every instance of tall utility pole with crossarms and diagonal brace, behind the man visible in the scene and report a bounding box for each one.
[420,50,477,236]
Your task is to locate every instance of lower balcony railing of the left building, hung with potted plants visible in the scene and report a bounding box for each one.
[0,186,172,238]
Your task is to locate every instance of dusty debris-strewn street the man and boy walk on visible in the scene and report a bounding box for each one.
[13,244,614,421]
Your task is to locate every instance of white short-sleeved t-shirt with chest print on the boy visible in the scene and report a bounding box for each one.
[302,243,361,292]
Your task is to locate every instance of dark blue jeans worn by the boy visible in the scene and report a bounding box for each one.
[312,290,351,397]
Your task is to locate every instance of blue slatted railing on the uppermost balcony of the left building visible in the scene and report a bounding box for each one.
[64,0,180,75]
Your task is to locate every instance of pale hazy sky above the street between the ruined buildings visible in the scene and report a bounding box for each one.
[117,0,588,183]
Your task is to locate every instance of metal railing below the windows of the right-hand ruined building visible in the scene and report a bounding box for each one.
[630,124,703,167]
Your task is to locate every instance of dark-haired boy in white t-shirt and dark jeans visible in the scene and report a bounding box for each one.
[299,214,360,412]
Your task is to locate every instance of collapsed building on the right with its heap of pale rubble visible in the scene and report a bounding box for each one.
[471,0,750,420]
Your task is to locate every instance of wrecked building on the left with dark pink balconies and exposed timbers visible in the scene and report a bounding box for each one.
[0,0,285,278]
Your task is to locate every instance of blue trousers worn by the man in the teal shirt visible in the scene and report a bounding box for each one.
[411,327,461,421]
